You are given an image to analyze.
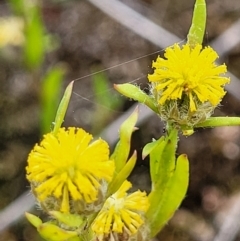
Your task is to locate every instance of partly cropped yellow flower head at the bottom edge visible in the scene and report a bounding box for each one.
[92,181,149,240]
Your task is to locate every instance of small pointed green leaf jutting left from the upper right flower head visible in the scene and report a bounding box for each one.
[114,84,158,113]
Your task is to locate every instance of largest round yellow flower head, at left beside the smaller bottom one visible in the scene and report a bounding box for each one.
[26,127,115,212]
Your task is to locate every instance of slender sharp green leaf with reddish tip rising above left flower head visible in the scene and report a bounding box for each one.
[53,81,74,135]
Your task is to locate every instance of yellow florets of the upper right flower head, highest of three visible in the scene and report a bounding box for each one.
[148,44,229,113]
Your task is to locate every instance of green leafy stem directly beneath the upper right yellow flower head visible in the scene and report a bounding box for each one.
[145,129,188,237]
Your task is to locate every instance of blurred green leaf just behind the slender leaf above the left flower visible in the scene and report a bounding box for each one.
[41,65,66,134]
